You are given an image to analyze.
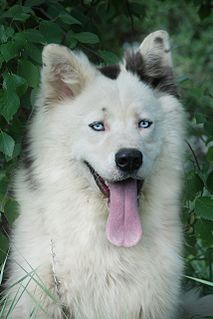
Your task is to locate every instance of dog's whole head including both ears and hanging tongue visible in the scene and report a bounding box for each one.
[39,31,180,247]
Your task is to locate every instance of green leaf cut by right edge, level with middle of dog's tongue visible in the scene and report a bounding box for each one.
[195,196,213,220]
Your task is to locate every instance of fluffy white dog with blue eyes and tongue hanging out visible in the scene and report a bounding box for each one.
[4,30,213,319]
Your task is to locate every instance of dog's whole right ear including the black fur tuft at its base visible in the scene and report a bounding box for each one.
[125,30,178,97]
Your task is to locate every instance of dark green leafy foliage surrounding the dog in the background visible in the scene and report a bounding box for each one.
[0,0,213,302]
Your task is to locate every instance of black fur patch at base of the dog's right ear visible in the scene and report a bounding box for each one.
[126,52,179,98]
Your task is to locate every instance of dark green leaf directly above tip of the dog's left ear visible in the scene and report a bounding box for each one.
[39,21,63,43]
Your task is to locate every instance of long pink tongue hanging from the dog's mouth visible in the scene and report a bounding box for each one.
[106,179,142,247]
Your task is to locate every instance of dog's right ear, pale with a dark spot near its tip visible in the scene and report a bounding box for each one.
[139,30,178,96]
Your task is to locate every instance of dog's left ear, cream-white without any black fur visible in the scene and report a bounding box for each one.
[41,44,95,101]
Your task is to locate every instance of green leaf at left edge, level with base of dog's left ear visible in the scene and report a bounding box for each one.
[0,89,20,123]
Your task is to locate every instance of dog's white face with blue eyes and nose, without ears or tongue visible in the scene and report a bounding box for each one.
[67,71,163,183]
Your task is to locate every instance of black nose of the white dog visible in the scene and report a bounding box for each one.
[115,148,143,173]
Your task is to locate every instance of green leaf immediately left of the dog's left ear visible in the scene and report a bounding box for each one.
[18,60,39,88]
